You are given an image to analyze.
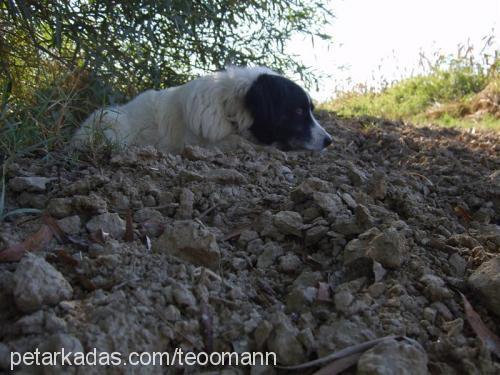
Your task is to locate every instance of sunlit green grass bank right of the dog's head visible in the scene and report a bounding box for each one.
[321,51,500,131]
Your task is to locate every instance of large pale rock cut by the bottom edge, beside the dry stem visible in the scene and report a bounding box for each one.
[356,339,428,375]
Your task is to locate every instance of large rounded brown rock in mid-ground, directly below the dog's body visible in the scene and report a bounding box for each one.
[153,220,220,269]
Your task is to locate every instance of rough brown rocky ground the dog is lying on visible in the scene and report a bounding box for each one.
[0,113,500,374]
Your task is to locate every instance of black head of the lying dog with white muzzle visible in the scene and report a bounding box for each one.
[245,74,332,150]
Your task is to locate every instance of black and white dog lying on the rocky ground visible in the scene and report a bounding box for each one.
[72,67,332,152]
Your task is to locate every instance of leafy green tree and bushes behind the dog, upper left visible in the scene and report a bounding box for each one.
[0,0,331,159]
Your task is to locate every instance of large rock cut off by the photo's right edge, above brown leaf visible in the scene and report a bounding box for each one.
[467,256,500,316]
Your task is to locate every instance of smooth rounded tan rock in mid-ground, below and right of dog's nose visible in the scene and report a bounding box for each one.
[366,228,407,268]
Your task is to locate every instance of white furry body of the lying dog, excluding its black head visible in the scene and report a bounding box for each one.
[72,67,276,152]
